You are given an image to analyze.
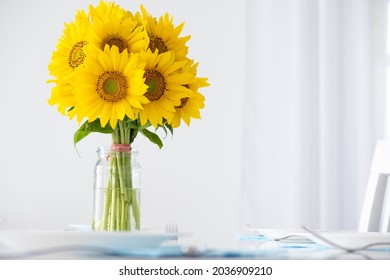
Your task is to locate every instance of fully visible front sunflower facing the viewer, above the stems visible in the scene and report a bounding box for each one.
[73,46,149,128]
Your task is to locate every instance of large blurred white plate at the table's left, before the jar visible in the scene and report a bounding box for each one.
[0,230,175,252]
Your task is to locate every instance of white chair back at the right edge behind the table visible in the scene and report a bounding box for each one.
[359,140,390,232]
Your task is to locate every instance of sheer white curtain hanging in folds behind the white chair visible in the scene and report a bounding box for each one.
[241,0,386,229]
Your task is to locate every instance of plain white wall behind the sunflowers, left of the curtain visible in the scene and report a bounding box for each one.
[0,0,245,236]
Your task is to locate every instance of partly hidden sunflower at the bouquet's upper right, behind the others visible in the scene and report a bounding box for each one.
[140,5,191,60]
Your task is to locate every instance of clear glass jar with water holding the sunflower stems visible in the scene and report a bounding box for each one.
[92,144,141,231]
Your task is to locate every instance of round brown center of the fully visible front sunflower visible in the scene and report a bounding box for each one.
[96,71,127,102]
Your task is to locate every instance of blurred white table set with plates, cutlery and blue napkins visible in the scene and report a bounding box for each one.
[0,221,390,260]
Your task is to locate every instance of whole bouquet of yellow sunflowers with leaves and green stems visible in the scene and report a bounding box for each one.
[48,1,208,230]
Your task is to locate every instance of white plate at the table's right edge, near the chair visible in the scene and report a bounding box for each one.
[310,231,390,249]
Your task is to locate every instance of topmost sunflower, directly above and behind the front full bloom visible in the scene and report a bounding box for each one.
[87,1,149,53]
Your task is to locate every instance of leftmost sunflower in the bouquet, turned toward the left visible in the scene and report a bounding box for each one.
[49,11,89,79]
